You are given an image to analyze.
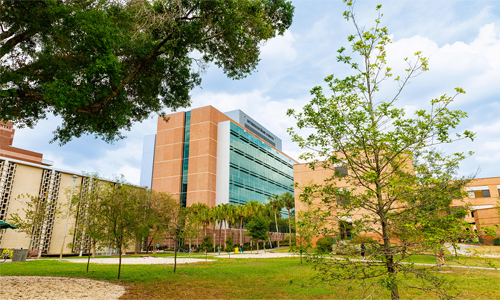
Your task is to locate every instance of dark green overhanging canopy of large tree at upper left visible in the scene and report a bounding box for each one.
[0,0,294,144]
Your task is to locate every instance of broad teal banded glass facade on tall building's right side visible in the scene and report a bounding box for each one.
[229,123,293,205]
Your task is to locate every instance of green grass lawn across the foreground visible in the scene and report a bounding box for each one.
[0,256,500,299]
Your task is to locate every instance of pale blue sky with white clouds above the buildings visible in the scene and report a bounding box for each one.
[9,0,500,184]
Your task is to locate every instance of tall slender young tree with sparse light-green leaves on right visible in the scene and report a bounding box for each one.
[288,1,474,299]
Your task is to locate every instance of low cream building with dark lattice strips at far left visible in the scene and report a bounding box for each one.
[0,156,84,255]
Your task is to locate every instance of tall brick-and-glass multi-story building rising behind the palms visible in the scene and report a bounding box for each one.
[141,106,296,207]
